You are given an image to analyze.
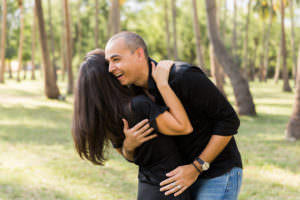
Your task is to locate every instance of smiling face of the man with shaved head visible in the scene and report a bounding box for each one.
[105,38,139,85]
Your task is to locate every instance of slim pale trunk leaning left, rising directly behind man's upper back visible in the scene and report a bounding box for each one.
[192,0,207,74]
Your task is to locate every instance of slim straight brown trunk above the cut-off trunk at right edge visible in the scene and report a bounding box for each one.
[280,0,292,92]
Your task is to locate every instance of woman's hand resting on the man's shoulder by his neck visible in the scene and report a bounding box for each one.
[151,60,174,85]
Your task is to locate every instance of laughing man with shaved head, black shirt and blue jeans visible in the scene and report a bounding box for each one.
[105,32,242,200]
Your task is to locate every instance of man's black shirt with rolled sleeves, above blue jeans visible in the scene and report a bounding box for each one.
[135,59,242,178]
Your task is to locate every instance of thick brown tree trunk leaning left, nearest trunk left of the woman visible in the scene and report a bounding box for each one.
[35,0,60,99]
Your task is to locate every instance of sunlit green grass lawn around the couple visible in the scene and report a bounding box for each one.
[0,75,300,200]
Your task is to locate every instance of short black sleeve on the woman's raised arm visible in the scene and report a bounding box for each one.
[131,95,169,131]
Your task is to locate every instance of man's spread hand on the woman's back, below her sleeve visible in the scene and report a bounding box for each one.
[122,119,157,152]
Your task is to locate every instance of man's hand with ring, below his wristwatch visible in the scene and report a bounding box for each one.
[160,164,200,197]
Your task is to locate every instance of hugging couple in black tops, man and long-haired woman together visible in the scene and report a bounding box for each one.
[72,32,243,200]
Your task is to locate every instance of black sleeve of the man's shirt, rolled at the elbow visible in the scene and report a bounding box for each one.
[177,67,240,136]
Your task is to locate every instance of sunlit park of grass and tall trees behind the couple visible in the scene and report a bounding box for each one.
[0,0,300,200]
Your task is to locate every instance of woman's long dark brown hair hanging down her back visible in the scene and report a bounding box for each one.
[72,49,132,165]
